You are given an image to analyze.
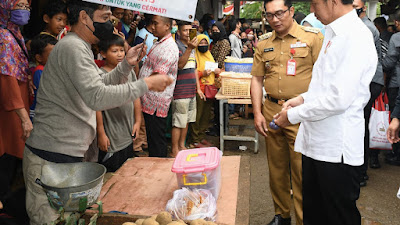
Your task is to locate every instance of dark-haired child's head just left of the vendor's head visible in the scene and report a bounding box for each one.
[40,0,67,40]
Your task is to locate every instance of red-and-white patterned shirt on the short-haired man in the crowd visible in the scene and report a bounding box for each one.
[139,34,179,117]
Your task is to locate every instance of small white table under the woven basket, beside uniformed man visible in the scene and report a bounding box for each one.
[215,90,258,153]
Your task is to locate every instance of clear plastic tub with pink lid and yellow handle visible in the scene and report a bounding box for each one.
[172,147,222,200]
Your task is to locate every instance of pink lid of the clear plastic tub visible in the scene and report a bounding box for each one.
[171,147,221,173]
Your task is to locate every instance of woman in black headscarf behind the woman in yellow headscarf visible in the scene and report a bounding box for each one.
[210,21,231,69]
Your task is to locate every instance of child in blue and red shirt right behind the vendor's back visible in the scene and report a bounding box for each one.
[29,34,57,121]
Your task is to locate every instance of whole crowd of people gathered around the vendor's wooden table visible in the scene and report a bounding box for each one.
[0,0,400,225]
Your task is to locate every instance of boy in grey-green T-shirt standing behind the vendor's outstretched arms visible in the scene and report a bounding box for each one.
[96,35,142,172]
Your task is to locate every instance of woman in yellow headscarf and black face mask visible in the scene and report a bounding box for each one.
[190,34,221,148]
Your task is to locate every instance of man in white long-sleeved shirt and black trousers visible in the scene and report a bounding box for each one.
[275,0,378,225]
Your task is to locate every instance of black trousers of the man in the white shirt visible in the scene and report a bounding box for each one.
[302,155,361,225]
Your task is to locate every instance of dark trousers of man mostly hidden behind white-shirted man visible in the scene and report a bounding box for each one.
[360,82,383,172]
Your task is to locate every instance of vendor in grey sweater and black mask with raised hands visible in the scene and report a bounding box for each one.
[23,0,172,224]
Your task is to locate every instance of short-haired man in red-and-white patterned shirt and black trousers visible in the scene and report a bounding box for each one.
[139,16,179,157]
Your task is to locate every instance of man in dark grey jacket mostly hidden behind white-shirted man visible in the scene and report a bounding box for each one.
[353,0,385,187]
